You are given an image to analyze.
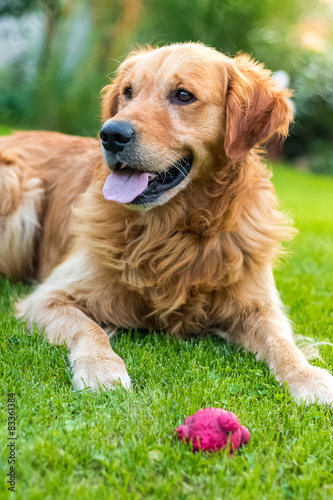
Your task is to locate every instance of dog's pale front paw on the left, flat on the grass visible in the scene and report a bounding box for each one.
[70,353,131,391]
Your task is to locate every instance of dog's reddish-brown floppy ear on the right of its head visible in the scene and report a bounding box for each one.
[224,55,292,162]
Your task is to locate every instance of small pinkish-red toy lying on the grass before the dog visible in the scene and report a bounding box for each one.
[176,408,250,455]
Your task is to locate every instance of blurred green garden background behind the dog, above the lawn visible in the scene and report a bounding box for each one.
[0,0,333,175]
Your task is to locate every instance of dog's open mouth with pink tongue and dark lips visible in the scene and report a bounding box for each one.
[103,157,193,205]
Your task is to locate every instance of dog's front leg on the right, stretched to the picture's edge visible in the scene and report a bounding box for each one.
[225,296,333,408]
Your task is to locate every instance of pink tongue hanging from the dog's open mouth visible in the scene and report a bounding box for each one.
[103,170,151,203]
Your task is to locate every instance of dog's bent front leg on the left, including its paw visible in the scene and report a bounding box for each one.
[16,254,130,390]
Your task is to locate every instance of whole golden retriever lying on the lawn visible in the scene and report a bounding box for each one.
[0,43,333,405]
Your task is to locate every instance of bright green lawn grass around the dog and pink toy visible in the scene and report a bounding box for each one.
[0,167,333,500]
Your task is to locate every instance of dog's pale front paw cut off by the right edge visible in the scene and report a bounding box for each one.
[288,366,333,409]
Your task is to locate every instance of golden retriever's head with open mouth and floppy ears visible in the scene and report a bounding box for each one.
[100,44,292,208]
